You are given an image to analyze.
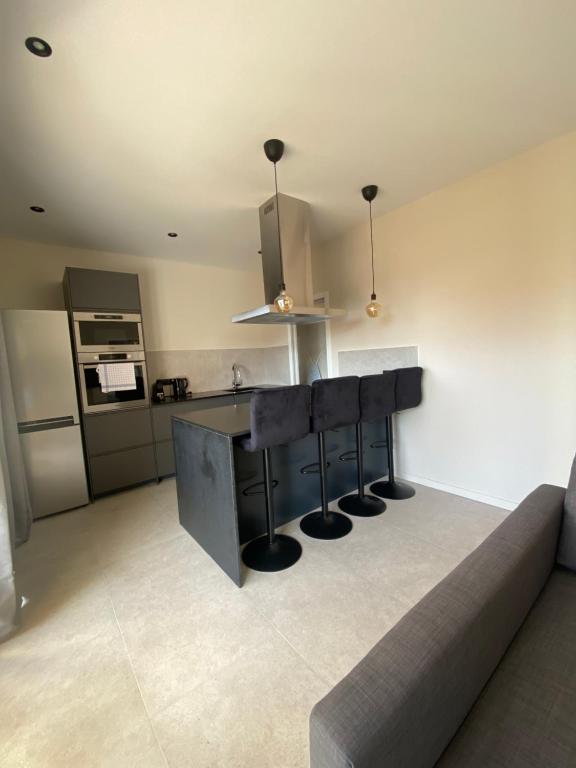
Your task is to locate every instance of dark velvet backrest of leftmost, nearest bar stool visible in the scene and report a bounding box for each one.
[242,384,310,451]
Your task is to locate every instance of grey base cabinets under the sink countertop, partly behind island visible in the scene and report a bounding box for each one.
[152,392,250,477]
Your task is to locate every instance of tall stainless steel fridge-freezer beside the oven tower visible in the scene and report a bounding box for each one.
[2,309,89,519]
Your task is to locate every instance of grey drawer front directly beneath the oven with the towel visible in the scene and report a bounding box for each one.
[84,408,154,456]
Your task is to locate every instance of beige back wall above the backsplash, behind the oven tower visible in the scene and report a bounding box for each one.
[0,239,287,350]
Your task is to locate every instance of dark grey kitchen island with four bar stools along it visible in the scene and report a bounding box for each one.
[172,404,386,586]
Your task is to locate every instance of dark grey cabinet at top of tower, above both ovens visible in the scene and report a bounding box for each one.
[64,267,140,312]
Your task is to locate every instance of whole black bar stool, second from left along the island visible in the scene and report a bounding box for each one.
[300,376,360,539]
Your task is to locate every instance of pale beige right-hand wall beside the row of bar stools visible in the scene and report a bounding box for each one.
[315,134,576,504]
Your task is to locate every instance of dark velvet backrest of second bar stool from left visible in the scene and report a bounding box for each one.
[310,376,360,432]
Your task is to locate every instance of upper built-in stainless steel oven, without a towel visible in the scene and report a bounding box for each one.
[73,312,144,354]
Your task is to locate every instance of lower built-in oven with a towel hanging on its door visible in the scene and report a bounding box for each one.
[78,352,150,414]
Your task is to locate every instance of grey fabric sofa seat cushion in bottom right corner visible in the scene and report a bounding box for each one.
[437,570,576,768]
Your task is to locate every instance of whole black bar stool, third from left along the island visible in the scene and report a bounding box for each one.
[338,371,395,517]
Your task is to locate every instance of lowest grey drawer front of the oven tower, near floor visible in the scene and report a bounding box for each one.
[89,445,157,496]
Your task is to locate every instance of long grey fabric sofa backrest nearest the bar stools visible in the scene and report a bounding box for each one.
[310,485,565,768]
